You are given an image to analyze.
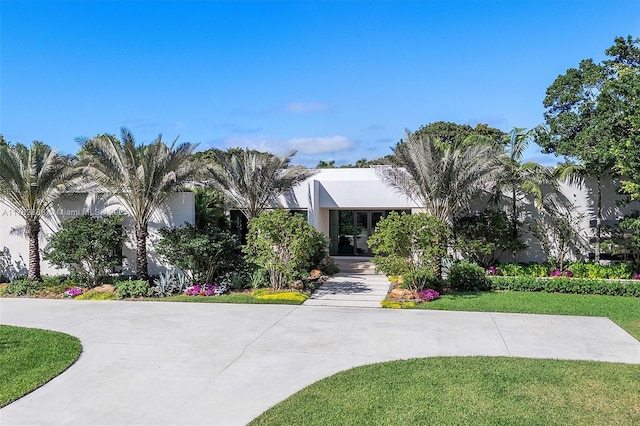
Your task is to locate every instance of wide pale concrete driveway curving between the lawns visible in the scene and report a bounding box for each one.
[0,299,640,426]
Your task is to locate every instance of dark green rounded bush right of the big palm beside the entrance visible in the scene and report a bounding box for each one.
[453,209,525,268]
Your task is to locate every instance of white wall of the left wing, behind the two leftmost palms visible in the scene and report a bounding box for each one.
[0,192,195,275]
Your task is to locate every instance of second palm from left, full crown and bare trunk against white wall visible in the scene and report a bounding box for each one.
[79,127,198,279]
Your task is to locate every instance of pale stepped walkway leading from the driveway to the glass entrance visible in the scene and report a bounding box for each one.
[304,256,391,308]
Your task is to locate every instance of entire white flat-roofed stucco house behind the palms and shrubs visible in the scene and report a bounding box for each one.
[0,168,640,274]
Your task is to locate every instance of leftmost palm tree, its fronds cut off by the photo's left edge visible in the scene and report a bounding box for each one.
[0,141,77,281]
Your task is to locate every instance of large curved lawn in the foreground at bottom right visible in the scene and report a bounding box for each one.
[250,357,640,425]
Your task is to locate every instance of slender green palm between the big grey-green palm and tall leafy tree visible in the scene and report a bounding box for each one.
[492,127,558,240]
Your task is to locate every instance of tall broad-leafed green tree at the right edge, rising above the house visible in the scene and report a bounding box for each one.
[538,36,640,261]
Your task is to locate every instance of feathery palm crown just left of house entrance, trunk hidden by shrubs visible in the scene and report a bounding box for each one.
[209,149,316,221]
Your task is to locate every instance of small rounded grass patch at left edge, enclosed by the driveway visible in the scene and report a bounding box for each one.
[0,325,82,407]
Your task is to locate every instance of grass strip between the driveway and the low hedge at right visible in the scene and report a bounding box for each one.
[414,291,640,340]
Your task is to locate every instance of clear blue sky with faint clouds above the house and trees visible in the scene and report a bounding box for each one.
[0,0,640,166]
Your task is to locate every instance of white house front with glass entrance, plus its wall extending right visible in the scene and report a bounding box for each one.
[280,167,640,262]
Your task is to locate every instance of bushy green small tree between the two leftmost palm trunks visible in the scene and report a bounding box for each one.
[43,215,126,287]
